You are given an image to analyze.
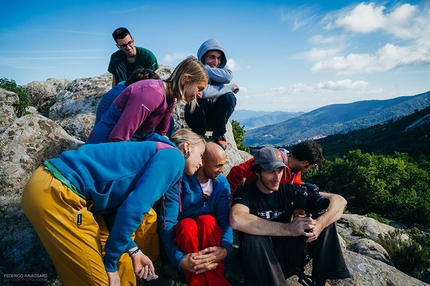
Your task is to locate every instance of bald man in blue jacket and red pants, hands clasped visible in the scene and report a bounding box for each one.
[159,142,233,286]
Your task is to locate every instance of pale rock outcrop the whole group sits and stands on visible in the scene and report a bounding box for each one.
[0,71,427,285]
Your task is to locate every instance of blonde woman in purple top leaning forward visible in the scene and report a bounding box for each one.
[86,57,209,144]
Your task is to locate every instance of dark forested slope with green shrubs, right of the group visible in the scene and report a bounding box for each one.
[303,107,430,277]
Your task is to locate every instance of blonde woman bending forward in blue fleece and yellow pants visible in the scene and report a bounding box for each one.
[22,129,205,286]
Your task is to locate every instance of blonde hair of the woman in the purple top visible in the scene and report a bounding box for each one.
[165,56,209,111]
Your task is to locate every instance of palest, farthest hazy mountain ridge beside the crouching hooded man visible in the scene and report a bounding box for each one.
[230,109,304,130]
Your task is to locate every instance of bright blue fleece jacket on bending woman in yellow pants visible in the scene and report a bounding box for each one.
[49,134,185,272]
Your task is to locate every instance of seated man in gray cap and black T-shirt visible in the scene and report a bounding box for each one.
[230,147,350,285]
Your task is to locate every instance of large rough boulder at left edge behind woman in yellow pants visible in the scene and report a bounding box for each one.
[0,114,83,285]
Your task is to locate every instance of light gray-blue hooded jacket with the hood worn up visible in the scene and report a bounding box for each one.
[197,39,234,101]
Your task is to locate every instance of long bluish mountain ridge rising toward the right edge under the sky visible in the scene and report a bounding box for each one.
[242,91,430,147]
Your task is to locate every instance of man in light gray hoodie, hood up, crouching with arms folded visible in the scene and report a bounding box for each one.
[185,39,239,150]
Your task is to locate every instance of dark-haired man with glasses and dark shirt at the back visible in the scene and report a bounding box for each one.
[108,27,158,87]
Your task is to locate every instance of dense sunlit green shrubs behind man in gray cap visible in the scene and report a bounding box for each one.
[306,150,430,228]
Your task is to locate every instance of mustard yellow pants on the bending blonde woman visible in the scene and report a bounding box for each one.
[22,166,158,286]
